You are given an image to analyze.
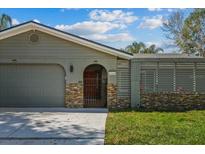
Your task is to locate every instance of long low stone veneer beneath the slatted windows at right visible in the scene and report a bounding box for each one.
[140,92,205,111]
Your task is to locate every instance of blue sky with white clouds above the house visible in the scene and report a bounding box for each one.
[0,8,193,53]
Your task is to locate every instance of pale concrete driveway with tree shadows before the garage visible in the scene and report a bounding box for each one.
[0,108,107,144]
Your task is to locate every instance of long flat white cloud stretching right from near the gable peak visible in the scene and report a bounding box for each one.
[55,21,124,35]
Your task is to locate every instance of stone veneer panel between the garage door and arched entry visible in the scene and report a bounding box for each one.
[65,83,83,108]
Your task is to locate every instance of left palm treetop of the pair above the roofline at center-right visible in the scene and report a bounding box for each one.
[125,42,145,53]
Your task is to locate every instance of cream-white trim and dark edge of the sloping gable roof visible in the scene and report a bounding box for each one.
[0,20,133,59]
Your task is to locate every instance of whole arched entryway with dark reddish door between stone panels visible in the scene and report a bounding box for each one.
[84,64,107,107]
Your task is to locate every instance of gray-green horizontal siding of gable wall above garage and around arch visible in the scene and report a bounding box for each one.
[0,31,117,83]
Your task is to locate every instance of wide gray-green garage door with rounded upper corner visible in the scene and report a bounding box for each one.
[0,65,65,107]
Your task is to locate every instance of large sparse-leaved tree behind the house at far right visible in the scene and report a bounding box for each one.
[162,9,205,57]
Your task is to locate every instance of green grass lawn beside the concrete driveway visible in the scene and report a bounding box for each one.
[105,110,205,144]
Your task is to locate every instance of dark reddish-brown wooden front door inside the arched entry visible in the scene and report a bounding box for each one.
[84,69,105,107]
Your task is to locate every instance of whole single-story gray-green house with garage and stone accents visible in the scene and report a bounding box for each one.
[0,21,205,109]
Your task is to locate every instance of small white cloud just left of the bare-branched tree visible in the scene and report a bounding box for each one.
[138,15,164,29]
